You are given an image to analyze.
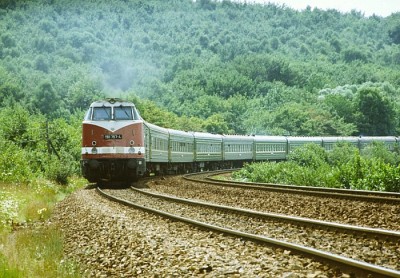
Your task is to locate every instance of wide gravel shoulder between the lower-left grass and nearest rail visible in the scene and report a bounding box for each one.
[51,189,349,278]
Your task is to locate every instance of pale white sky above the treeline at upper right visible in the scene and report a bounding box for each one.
[240,0,400,17]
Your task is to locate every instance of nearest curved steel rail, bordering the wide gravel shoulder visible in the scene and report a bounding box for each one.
[97,188,400,277]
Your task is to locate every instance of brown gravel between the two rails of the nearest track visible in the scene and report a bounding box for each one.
[106,189,400,269]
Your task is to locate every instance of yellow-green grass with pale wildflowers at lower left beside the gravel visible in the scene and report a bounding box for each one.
[0,179,85,277]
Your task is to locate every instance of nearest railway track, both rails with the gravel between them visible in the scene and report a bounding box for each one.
[98,189,400,277]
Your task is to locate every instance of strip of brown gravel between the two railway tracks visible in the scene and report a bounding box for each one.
[147,176,400,231]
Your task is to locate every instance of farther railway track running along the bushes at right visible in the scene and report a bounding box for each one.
[184,170,400,205]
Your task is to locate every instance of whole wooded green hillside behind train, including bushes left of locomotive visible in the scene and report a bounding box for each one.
[0,0,400,183]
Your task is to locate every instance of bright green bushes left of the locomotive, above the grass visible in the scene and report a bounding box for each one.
[0,104,81,184]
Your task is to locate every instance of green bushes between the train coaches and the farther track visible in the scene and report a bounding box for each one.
[233,142,400,192]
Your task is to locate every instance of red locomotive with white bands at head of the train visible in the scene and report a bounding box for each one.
[81,99,146,182]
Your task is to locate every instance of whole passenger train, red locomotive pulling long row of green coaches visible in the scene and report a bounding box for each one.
[81,98,400,182]
